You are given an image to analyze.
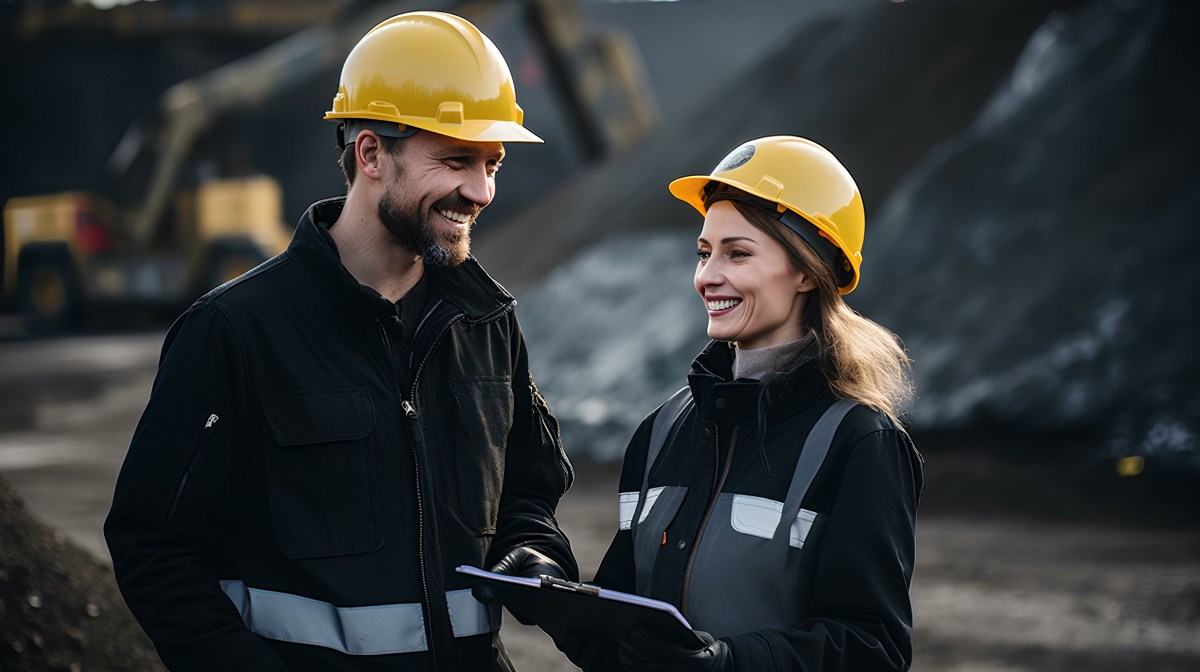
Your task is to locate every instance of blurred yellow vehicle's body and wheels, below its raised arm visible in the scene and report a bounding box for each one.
[4,175,290,334]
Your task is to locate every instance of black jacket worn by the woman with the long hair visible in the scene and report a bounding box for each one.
[594,342,923,672]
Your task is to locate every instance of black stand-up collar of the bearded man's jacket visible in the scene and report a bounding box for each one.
[288,197,516,322]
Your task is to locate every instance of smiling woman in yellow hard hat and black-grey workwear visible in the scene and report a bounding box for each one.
[559,136,923,672]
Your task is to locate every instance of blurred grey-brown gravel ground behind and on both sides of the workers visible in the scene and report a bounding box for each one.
[0,334,1200,672]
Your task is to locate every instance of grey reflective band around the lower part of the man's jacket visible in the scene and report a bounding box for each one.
[221,581,500,655]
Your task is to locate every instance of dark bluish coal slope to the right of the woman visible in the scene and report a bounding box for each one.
[856,1,1200,469]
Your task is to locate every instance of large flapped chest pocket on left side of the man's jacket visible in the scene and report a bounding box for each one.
[263,390,383,558]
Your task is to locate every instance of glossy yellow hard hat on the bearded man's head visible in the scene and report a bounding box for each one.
[325,12,542,143]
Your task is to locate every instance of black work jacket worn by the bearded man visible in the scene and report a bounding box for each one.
[104,199,577,672]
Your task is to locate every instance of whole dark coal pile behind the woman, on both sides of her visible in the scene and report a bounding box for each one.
[489,0,1200,478]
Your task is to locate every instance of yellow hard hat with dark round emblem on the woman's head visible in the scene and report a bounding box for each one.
[670,136,866,294]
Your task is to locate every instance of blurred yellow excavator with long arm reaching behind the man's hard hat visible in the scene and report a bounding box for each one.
[2,0,656,334]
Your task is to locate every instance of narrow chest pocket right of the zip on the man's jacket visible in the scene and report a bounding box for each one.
[450,377,514,534]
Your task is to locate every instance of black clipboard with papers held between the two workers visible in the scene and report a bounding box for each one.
[456,565,704,648]
